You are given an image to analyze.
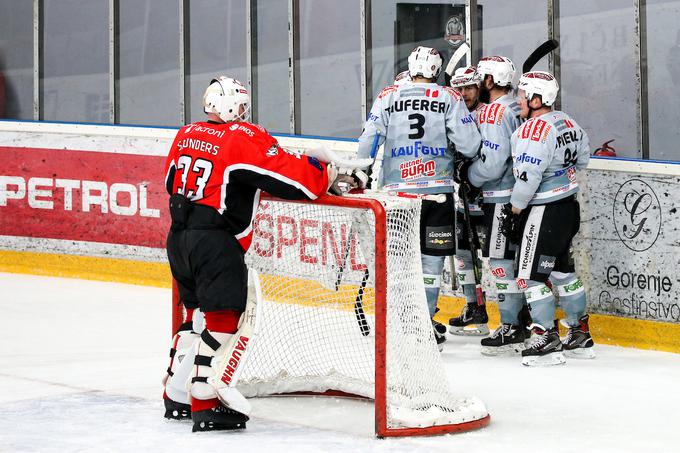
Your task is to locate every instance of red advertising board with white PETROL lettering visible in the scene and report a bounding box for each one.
[0,147,169,248]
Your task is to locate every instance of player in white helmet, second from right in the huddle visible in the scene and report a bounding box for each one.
[449,56,527,355]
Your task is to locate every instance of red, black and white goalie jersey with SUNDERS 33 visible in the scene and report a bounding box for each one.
[165,122,328,251]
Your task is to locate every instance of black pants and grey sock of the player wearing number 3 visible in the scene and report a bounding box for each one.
[420,193,456,317]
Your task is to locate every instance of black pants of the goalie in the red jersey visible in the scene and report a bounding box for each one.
[167,204,248,313]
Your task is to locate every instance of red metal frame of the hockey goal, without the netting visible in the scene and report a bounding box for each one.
[171,194,490,438]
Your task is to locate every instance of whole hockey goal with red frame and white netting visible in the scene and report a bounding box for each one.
[173,194,489,437]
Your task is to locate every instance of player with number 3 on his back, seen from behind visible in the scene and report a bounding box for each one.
[357,47,481,345]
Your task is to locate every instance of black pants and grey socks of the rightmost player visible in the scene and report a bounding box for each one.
[515,196,586,328]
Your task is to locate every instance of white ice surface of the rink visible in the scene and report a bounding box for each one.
[0,274,680,453]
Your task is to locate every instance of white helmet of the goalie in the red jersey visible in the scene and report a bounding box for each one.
[203,76,250,123]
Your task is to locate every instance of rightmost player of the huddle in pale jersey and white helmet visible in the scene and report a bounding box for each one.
[503,71,594,366]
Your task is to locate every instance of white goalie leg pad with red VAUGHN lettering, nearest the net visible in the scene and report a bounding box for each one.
[208,269,262,415]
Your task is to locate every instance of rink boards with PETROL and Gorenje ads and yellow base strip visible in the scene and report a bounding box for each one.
[0,121,680,352]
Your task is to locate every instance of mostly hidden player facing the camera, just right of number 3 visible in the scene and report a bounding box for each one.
[450,66,489,335]
